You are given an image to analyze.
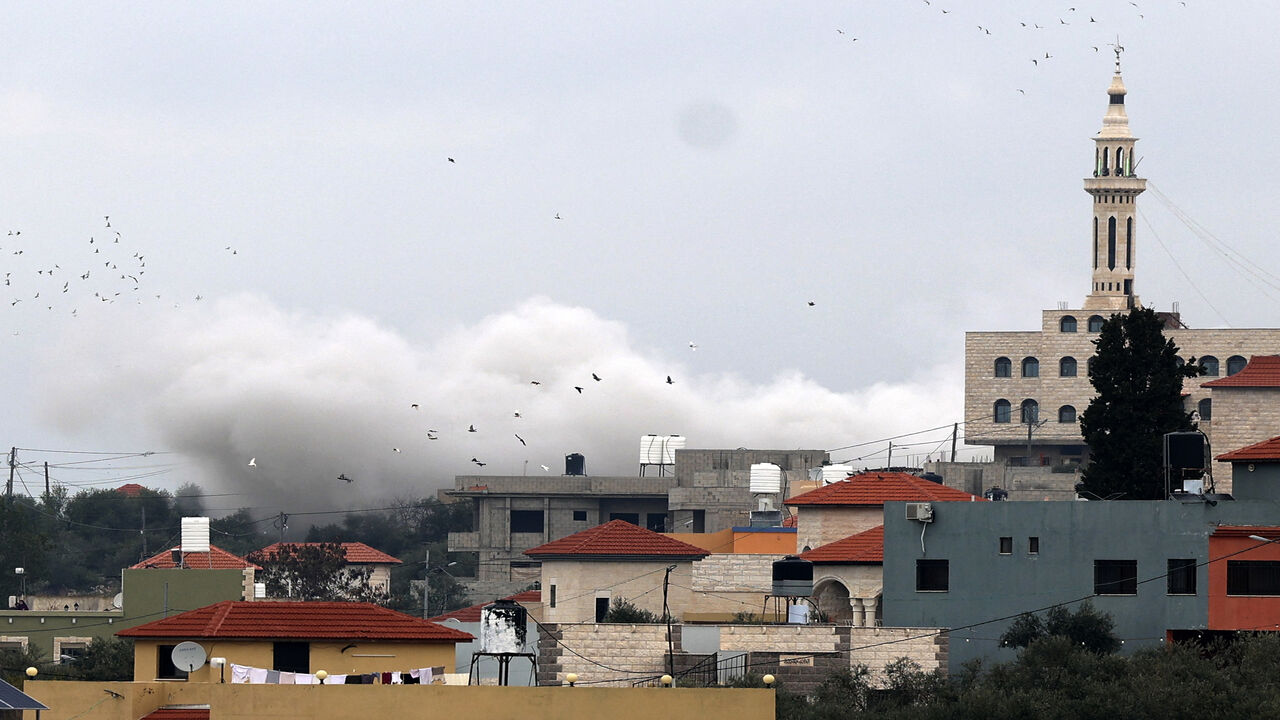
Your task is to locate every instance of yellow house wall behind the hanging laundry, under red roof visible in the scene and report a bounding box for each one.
[133,638,454,684]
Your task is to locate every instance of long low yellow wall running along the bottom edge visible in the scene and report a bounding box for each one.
[23,680,774,720]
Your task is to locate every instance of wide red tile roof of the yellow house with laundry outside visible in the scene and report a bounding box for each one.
[116,600,474,642]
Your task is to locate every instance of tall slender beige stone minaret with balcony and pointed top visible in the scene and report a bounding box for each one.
[1084,42,1147,310]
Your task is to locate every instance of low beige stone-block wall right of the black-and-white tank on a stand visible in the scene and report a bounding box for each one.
[538,623,948,693]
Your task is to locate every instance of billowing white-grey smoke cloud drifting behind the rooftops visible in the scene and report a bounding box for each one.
[40,296,961,511]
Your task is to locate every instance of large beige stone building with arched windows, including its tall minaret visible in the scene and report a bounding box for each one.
[965,53,1280,492]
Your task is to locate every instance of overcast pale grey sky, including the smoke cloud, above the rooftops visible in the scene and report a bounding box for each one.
[0,0,1280,507]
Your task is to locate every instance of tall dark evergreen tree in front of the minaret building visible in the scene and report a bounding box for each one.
[1080,307,1203,500]
